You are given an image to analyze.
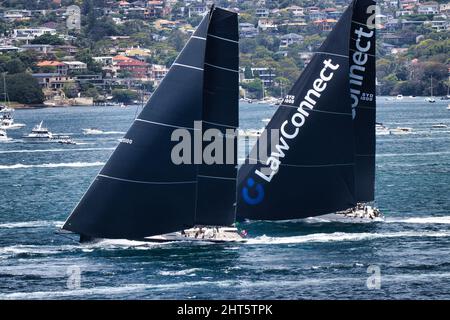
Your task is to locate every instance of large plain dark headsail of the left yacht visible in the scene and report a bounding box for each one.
[63,6,237,239]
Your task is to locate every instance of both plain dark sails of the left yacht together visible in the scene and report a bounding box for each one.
[63,8,238,239]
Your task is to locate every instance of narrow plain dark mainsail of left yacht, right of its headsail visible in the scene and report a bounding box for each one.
[195,8,239,226]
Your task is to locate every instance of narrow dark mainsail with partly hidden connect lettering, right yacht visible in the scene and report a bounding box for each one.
[349,0,376,202]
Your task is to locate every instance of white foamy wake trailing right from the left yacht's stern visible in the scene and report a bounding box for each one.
[246,231,450,245]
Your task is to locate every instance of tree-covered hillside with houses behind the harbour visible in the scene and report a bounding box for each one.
[0,0,450,106]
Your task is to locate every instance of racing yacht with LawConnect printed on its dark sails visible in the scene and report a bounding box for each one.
[237,0,377,220]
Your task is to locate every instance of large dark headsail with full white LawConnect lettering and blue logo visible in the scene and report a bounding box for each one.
[237,3,356,220]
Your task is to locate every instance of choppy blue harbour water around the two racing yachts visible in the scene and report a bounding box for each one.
[0,98,450,299]
